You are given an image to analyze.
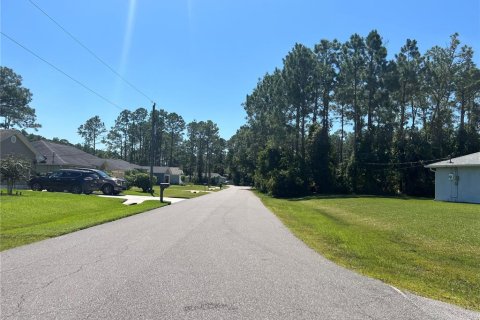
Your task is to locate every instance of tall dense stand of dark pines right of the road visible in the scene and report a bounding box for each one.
[227,30,480,196]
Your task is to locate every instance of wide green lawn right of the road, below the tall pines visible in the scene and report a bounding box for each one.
[258,194,480,310]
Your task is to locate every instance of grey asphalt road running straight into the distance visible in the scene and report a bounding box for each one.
[0,187,480,320]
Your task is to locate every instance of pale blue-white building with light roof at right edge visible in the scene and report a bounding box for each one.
[425,152,480,203]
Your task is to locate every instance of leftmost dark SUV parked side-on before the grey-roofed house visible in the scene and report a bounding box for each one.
[29,169,100,194]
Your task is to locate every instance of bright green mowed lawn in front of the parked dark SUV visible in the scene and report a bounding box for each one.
[0,191,165,251]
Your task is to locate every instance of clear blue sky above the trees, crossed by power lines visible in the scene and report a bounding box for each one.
[1,0,480,143]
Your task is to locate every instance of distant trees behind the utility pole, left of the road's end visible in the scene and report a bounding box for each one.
[77,108,226,182]
